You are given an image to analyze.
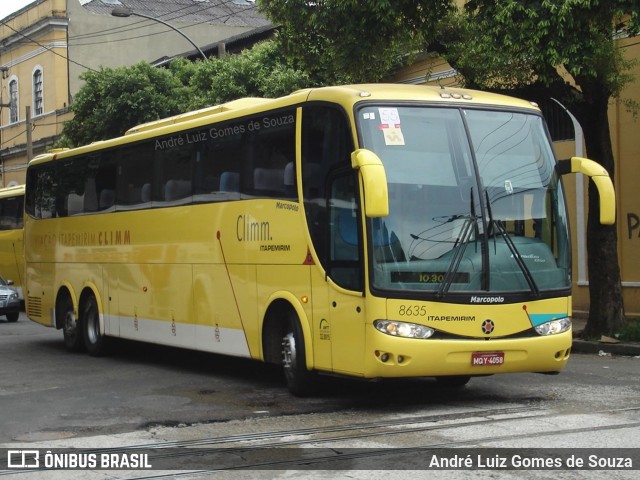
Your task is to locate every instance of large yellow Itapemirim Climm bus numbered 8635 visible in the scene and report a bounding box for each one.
[25,85,615,395]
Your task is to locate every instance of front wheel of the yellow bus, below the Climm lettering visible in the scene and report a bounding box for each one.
[282,314,316,397]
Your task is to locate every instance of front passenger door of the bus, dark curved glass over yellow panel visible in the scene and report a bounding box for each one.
[300,103,365,375]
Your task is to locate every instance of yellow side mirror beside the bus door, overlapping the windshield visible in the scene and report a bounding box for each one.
[351,148,389,217]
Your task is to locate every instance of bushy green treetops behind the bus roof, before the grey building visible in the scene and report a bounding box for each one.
[58,42,319,147]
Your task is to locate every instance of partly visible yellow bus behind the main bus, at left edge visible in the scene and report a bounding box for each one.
[0,185,24,300]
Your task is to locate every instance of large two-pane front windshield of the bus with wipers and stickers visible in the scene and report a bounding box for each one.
[357,105,571,296]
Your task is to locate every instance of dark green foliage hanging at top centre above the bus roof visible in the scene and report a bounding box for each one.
[258,0,452,83]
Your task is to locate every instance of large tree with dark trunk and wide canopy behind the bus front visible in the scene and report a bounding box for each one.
[260,0,640,336]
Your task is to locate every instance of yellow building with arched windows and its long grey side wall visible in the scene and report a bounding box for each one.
[0,0,273,188]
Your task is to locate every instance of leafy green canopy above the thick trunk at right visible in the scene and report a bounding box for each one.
[443,0,640,97]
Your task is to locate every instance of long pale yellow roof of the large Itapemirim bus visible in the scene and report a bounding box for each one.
[30,84,539,164]
